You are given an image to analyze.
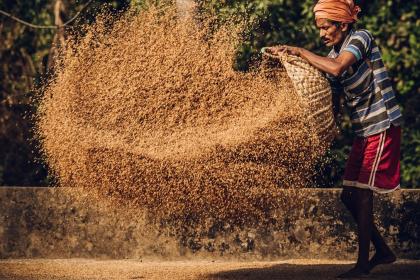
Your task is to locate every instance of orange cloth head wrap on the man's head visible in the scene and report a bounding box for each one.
[314,0,361,23]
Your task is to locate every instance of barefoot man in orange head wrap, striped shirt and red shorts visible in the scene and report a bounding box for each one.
[269,0,402,278]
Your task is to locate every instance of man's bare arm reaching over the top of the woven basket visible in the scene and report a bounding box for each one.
[270,46,357,77]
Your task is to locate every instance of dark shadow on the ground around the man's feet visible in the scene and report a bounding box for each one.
[207,263,420,280]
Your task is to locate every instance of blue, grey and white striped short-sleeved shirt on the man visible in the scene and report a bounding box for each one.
[327,30,402,137]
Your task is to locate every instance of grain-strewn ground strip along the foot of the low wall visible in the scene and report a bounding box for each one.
[0,259,420,280]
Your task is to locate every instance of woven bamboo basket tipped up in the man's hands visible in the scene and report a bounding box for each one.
[262,49,338,145]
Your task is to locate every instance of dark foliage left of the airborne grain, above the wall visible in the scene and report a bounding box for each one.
[0,0,127,186]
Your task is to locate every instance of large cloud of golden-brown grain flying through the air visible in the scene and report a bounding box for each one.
[38,3,328,225]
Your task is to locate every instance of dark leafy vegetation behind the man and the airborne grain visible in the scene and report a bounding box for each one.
[0,0,420,188]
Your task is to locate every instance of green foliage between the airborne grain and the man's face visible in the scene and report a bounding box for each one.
[197,0,321,70]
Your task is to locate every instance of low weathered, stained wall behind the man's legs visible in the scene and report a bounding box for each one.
[0,187,420,260]
